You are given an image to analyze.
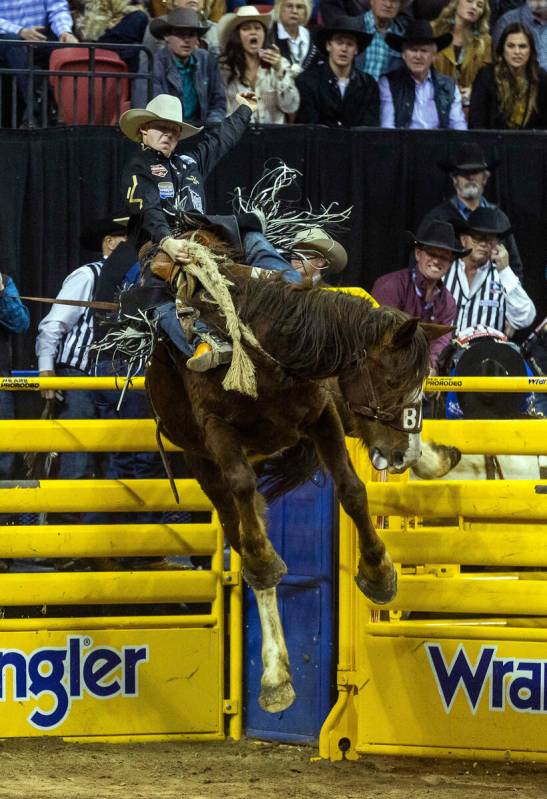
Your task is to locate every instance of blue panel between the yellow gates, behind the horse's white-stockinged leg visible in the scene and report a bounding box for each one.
[244,478,338,743]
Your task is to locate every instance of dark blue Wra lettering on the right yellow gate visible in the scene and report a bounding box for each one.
[425,644,547,713]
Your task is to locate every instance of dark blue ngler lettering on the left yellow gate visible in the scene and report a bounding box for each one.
[0,636,149,730]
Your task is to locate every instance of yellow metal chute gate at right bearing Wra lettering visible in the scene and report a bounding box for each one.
[320,388,547,761]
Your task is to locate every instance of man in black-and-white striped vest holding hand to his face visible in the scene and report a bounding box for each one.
[444,208,536,337]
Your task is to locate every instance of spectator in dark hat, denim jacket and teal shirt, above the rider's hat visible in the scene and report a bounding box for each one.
[150,8,226,127]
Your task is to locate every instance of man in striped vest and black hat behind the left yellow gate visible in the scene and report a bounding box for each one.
[36,217,127,488]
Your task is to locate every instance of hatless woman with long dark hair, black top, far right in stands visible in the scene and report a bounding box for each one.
[469,22,547,130]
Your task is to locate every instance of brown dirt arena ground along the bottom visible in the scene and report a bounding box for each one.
[0,739,547,799]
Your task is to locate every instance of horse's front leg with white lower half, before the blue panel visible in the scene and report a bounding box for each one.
[205,419,295,713]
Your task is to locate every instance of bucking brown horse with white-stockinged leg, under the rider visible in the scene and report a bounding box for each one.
[146,236,447,713]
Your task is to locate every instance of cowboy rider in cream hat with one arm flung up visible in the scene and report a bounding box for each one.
[120,93,300,372]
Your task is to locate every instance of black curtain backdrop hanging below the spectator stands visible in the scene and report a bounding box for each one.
[0,126,547,376]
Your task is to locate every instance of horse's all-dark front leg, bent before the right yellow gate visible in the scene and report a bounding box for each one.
[306,403,397,605]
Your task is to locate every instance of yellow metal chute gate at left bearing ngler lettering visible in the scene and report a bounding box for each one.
[0,384,242,741]
